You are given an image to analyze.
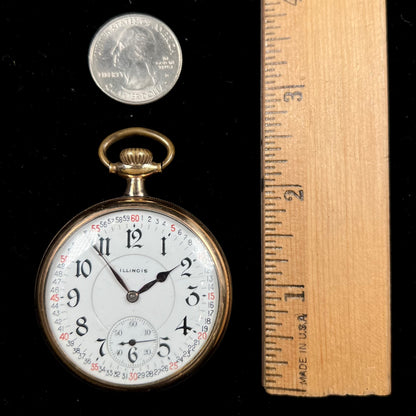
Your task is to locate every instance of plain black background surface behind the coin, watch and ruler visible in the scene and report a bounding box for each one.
[0,0,416,415]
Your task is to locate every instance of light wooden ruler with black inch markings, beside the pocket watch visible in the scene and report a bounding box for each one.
[262,0,390,396]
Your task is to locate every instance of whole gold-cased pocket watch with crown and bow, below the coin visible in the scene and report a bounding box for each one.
[36,127,231,390]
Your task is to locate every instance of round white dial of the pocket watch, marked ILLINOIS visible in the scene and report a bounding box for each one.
[42,203,229,388]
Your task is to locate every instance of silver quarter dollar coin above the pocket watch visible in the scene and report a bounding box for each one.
[88,14,182,104]
